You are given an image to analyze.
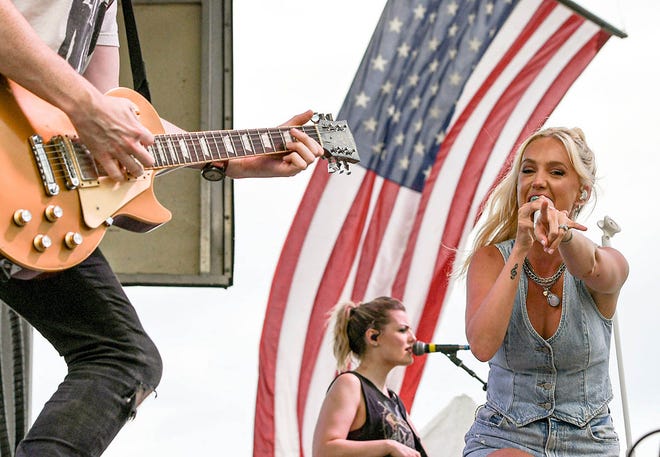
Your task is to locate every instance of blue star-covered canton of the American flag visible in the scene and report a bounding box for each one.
[337,0,516,191]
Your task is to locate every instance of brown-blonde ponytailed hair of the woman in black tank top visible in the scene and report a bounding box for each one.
[332,297,406,371]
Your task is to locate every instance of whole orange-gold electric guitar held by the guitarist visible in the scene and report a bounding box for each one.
[0,76,359,276]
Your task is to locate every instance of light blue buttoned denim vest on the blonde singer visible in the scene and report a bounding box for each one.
[487,240,612,427]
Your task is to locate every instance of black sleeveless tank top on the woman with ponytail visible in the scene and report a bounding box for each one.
[340,371,426,456]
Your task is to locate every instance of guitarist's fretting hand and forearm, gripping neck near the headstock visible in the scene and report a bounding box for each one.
[227,110,324,178]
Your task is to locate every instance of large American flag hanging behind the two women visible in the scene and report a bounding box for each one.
[254,0,610,457]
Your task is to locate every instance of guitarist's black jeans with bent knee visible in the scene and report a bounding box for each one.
[0,250,162,457]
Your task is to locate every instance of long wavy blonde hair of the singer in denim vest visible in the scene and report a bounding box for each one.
[462,127,596,272]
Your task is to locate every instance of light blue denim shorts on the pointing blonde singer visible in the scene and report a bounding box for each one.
[463,405,620,457]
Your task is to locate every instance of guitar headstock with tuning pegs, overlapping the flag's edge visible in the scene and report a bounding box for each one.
[312,113,360,174]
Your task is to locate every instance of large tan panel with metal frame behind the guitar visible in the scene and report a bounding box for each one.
[101,0,234,287]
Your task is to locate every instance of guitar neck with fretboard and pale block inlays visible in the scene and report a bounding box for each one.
[148,126,320,169]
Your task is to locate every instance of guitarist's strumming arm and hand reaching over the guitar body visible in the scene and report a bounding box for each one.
[0,0,153,180]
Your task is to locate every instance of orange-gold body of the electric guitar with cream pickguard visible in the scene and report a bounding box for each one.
[0,79,171,272]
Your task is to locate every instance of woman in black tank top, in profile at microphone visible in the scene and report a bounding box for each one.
[313,297,426,457]
